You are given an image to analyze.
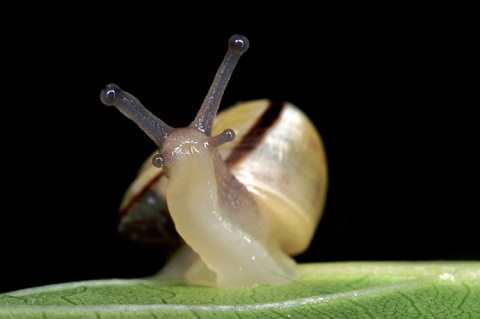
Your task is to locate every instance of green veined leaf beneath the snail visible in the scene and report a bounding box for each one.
[0,262,480,319]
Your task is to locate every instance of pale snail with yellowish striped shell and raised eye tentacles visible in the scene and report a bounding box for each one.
[100,35,327,287]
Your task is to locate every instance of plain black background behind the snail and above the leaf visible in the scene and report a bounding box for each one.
[0,1,480,292]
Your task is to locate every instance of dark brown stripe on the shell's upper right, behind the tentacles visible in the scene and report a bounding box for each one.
[225,101,285,167]
